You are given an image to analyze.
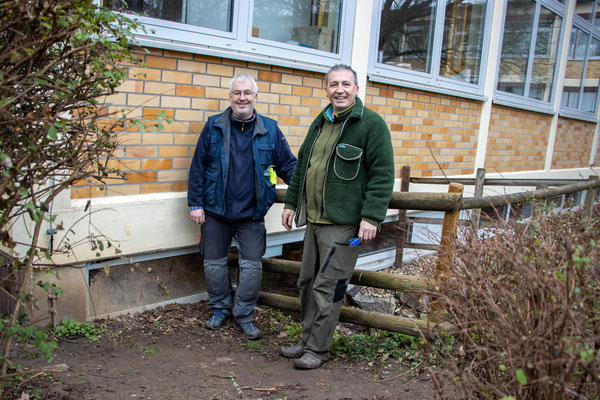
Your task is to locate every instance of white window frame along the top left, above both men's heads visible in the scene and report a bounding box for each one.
[102,0,357,72]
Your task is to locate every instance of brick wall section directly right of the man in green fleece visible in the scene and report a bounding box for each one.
[365,83,481,177]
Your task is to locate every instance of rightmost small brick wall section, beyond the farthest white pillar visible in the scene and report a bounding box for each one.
[552,118,595,169]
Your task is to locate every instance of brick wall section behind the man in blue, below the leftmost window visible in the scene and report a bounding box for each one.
[71,49,328,198]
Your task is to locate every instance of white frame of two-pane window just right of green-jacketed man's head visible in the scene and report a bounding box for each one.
[368,0,500,101]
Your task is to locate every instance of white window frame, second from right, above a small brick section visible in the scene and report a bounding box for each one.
[493,0,569,114]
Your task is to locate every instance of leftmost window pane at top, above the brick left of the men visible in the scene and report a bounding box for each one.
[107,0,232,32]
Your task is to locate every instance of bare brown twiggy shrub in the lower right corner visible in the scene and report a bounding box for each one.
[424,206,600,400]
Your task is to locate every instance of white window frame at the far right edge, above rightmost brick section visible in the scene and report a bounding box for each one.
[559,1,600,122]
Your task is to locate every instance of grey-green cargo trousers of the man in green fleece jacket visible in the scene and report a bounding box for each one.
[298,222,360,360]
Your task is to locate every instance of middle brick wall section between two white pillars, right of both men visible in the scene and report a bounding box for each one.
[485,105,552,173]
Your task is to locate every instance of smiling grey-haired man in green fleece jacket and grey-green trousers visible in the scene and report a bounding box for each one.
[280,64,395,369]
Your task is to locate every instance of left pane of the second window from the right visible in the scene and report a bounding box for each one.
[498,0,535,95]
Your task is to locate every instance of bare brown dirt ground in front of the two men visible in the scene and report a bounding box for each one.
[12,302,434,400]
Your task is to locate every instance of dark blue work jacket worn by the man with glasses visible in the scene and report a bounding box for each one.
[188,108,296,219]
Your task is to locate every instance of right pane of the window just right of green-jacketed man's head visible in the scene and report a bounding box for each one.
[440,0,487,84]
